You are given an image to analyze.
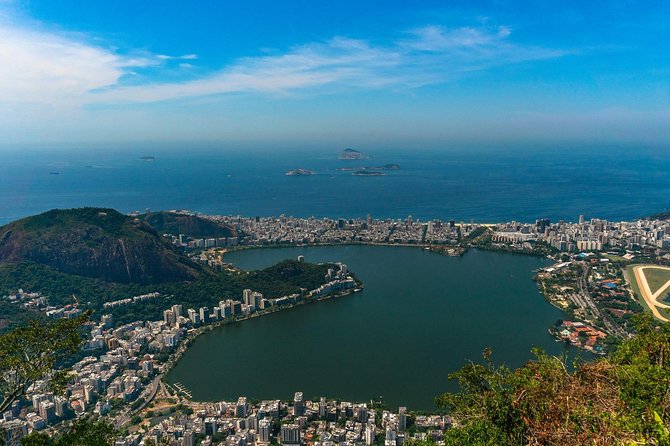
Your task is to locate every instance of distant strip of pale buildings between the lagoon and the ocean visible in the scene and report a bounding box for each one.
[178,215,670,259]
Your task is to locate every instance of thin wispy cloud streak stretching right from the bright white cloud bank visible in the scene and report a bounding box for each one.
[93,26,566,103]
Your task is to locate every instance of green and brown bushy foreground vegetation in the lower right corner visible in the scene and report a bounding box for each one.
[427,315,670,446]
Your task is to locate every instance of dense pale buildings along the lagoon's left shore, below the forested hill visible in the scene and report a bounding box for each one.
[0,264,356,446]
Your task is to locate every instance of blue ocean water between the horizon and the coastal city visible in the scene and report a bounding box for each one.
[0,146,670,224]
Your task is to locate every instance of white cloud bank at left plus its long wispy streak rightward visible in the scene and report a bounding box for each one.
[0,13,566,107]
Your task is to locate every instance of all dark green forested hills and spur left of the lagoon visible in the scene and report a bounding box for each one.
[0,208,342,330]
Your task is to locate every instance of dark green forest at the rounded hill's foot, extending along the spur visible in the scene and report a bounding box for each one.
[0,260,332,327]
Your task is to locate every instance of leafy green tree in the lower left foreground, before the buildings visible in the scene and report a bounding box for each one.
[0,312,90,413]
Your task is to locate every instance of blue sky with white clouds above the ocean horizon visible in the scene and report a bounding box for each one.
[0,0,670,149]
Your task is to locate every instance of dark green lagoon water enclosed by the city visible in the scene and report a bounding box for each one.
[169,246,562,409]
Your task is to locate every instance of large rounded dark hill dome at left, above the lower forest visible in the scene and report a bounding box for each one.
[0,208,204,284]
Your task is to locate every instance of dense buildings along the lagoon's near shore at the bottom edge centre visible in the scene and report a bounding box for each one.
[117,392,451,446]
